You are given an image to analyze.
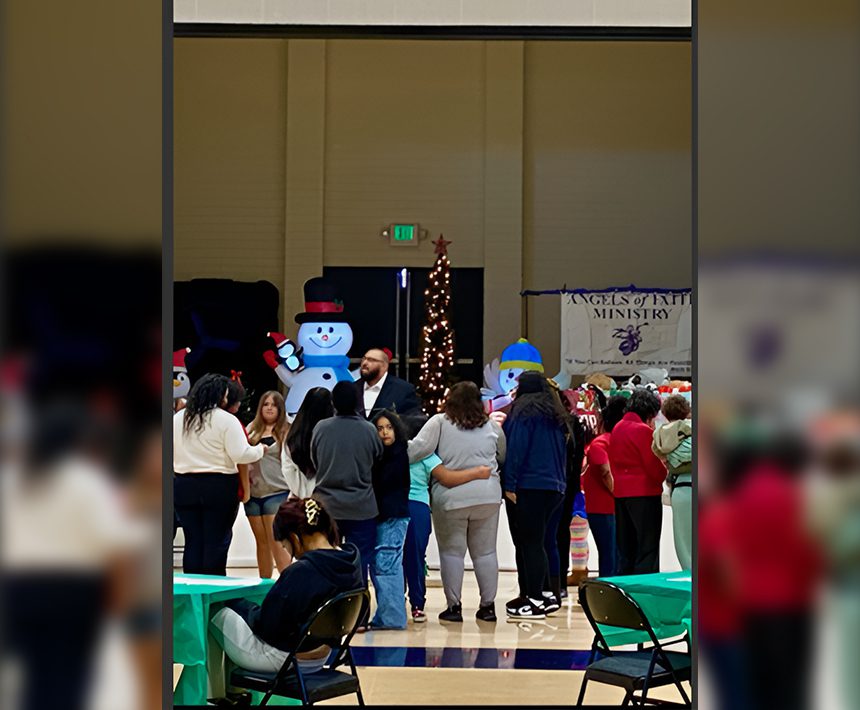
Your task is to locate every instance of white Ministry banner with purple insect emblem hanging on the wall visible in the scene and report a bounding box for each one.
[561,289,692,377]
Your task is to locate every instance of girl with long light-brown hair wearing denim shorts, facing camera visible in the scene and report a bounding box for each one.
[245,390,290,579]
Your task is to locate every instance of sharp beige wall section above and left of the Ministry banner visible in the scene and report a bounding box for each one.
[523,42,692,374]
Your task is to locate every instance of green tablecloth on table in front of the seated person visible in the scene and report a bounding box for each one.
[173,574,286,705]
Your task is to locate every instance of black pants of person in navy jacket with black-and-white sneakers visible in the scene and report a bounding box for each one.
[516,489,562,599]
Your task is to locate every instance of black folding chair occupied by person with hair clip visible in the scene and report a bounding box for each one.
[230,589,370,705]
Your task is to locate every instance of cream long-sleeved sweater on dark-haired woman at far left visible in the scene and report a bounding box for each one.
[173,408,266,473]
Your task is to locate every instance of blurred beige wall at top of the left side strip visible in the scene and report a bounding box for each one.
[0,2,162,246]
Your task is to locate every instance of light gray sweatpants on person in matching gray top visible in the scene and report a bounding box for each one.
[433,503,500,608]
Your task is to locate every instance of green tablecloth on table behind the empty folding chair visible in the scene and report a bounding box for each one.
[600,572,693,645]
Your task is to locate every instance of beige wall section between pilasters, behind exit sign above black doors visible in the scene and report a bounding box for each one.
[324,41,484,267]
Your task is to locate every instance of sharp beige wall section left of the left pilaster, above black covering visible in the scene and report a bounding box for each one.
[173,39,286,289]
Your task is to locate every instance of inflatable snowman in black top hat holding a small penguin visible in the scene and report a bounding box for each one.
[263,277,358,418]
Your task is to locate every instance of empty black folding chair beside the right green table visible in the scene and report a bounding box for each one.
[576,580,692,707]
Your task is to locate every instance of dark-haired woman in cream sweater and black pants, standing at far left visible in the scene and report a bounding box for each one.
[173,374,266,576]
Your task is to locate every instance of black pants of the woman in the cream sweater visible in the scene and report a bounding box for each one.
[173,473,239,577]
